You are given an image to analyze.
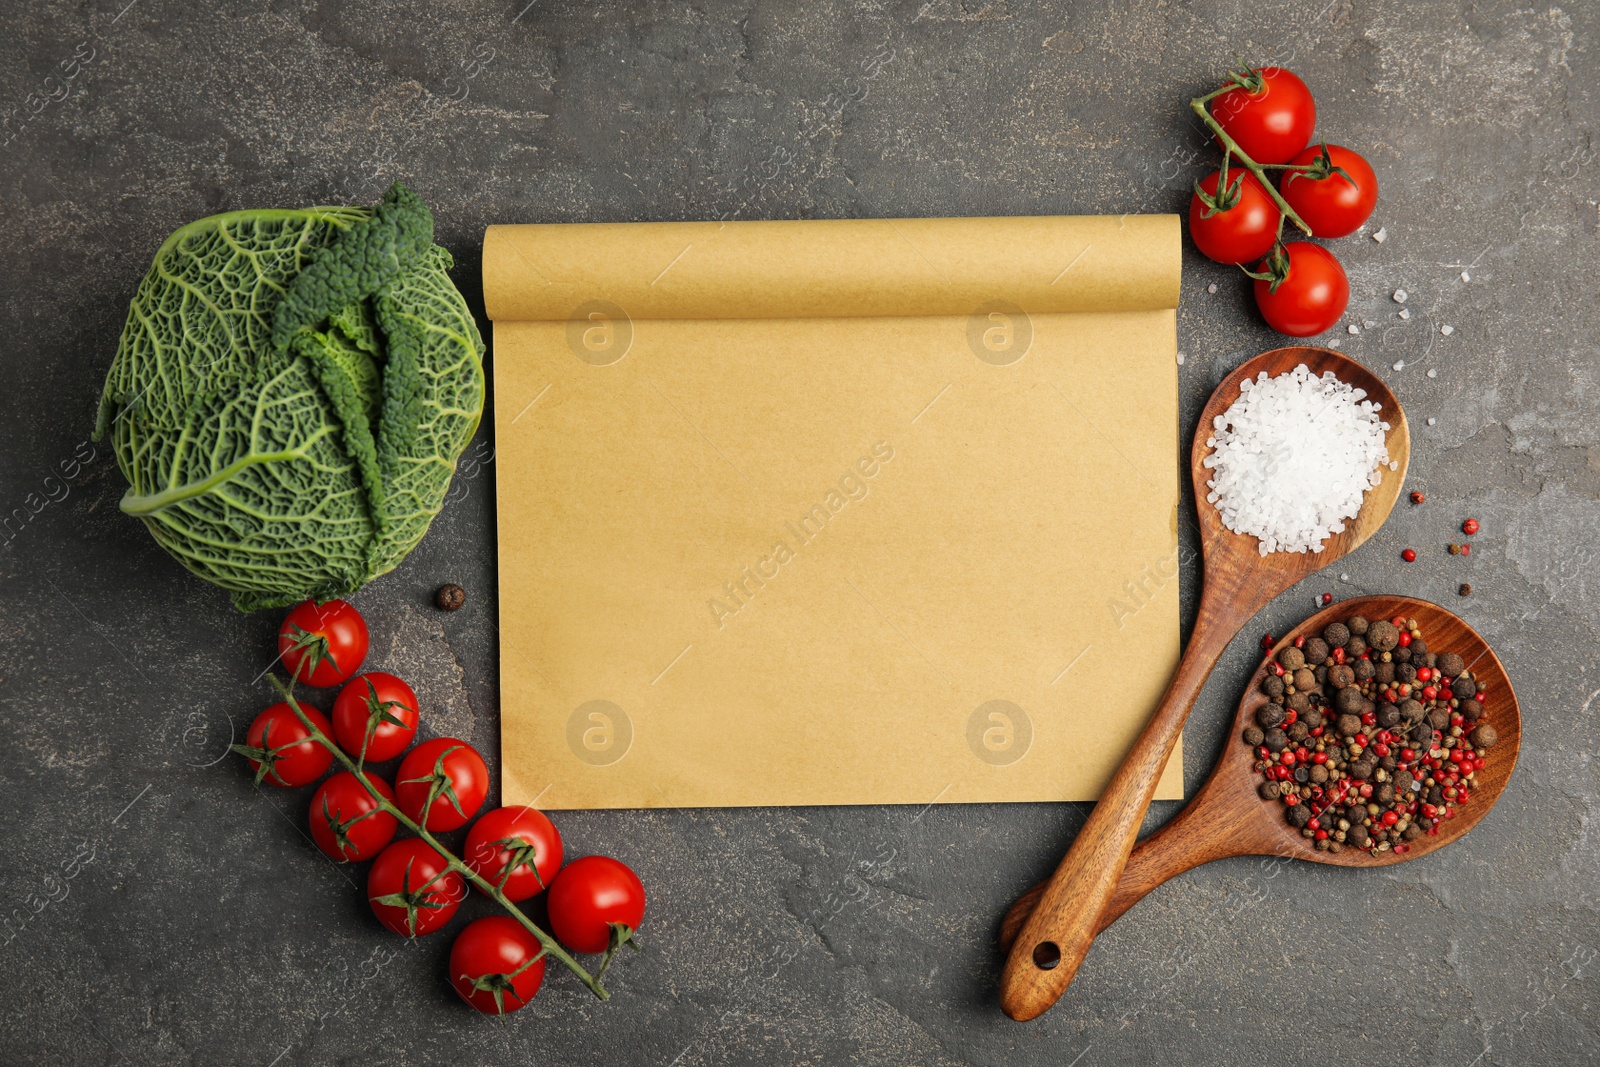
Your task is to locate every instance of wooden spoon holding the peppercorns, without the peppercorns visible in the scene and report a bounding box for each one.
[1000,597,1522,950]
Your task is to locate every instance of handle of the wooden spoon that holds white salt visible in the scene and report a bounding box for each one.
[1000,581,1241,1021]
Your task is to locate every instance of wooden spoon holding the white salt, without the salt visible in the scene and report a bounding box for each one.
[1000,347,1411,1021]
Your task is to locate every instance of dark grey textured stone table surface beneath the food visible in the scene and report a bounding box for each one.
[0,0,1600,1067]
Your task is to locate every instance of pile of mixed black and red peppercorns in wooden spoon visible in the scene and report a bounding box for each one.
[1243,616,1499,853]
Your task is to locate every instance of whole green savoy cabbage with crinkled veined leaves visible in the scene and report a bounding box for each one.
[96,184,485,611]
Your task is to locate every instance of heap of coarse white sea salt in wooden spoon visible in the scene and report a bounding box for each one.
[1203,363,1389,555]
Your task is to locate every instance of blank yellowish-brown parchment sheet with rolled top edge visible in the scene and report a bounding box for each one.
[483,216,1182,808]
